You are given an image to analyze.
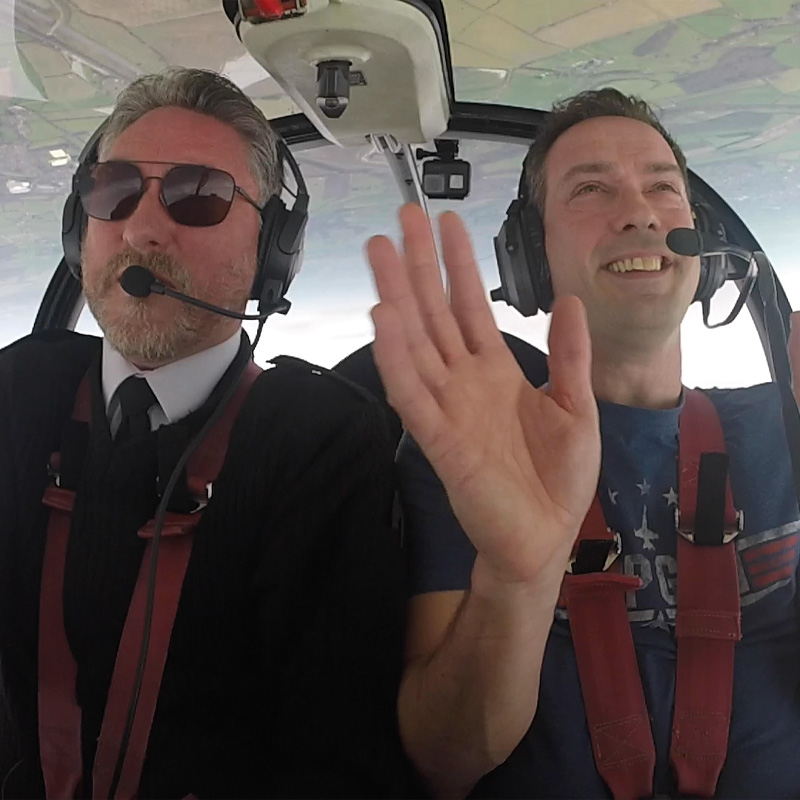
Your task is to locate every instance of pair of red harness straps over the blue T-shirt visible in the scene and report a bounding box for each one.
[564,390,741,798]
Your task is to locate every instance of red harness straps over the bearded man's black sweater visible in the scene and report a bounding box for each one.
[39,362,261,798]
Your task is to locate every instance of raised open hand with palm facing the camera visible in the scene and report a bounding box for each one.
[367,205,600,582]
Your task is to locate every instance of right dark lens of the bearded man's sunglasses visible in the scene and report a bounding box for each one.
[162,164,235,227]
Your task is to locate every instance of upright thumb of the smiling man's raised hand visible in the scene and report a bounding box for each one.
[548,296,596,414]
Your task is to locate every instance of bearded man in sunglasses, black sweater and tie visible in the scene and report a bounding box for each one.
[0,69,410,798]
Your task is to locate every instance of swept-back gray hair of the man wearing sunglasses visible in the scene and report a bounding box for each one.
[98,67,282,205]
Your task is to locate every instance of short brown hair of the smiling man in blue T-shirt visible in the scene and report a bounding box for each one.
[522,87,689,214]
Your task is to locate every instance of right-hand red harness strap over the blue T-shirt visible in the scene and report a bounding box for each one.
[670,391,742,797]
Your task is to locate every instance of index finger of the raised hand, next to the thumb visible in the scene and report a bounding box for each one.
[439,212,503,352]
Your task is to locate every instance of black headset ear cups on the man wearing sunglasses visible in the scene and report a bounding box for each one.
[61,120,308,313]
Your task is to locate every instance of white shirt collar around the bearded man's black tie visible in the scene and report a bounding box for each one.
[102,331,241,423]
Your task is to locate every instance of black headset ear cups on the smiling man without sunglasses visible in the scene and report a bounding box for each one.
[491,162,736,317]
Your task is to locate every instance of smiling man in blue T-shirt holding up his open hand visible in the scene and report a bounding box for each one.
[369,89,800,798]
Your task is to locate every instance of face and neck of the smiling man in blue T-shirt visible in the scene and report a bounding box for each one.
[526,108,700,408]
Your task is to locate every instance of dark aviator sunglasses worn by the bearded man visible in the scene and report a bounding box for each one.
[77,161,261,228]
